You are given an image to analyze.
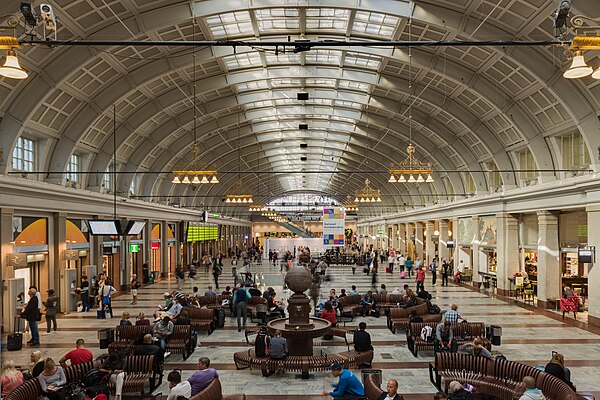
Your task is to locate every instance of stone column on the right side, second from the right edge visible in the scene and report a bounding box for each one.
[537,211,560,308]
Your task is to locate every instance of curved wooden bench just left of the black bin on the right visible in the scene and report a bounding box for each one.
[406,322,492,357]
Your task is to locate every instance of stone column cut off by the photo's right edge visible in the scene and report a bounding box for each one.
[584,208,600,326]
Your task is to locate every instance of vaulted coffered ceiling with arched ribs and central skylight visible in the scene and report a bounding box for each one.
[0,0,600,219]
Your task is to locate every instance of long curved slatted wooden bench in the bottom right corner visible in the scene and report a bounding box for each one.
[429,353,576,400]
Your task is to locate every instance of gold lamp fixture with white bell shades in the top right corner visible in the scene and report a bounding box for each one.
[563,15,600,79]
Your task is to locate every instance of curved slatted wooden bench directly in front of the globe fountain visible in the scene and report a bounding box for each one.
[233,349,373,377]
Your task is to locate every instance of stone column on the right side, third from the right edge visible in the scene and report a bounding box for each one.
[496,213,519,296]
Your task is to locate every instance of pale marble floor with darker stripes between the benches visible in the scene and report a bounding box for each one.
[1,265,600,400]
